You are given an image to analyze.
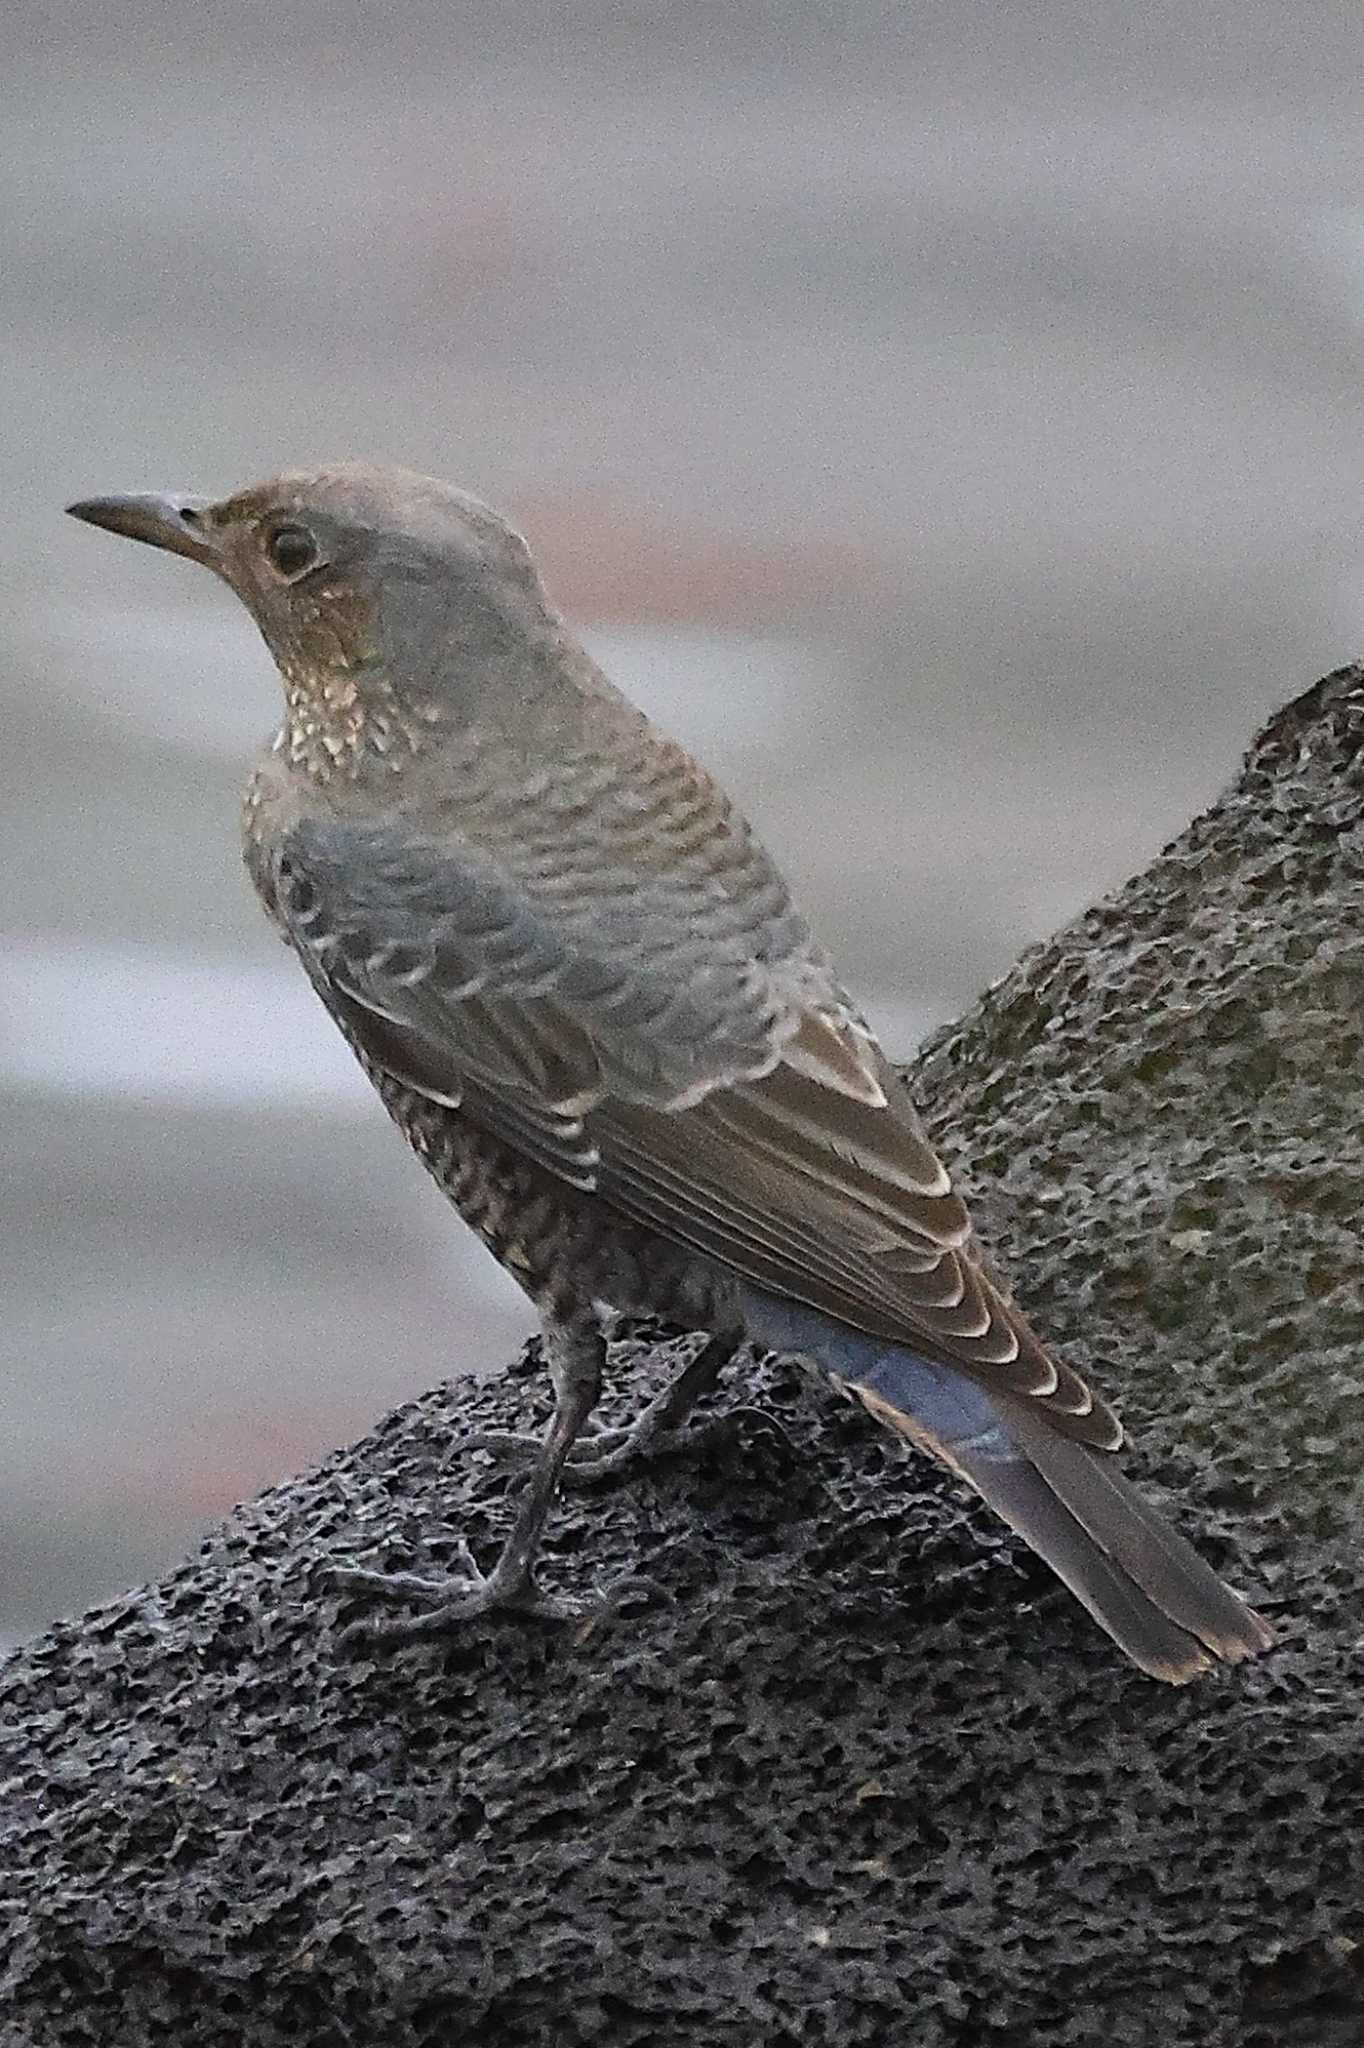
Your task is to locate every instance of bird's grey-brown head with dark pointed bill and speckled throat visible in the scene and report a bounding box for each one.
[68,463,559,776]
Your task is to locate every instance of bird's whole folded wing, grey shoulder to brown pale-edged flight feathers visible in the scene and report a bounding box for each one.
[272,819,1118,1442]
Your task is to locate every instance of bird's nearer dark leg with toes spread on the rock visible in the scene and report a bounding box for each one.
[330,1317,604,1642]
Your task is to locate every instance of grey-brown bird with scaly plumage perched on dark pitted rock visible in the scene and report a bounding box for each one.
[68,463,1272,1683]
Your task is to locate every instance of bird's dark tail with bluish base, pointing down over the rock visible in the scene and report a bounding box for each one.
[846,1350,1274,1686]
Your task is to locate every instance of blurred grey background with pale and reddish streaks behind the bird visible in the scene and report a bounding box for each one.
[0,0,1364,1640]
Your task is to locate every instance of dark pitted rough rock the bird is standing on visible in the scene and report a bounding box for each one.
[0,670,1364,2048]
